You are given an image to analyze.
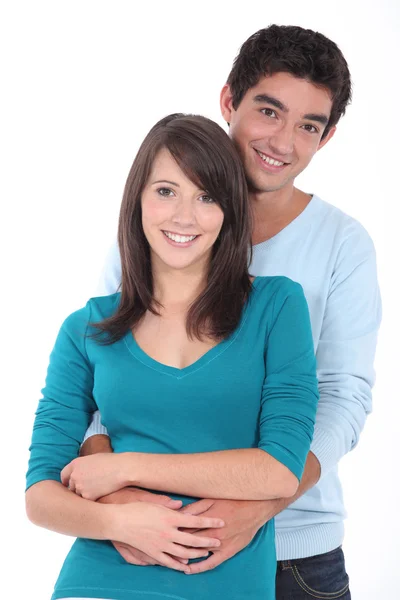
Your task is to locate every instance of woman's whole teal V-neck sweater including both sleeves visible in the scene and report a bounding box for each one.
[27,277,318,600]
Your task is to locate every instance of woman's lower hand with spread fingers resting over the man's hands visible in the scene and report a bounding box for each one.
[110,502,224,572]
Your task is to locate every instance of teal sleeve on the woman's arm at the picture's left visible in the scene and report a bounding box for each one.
[27,304,97,488]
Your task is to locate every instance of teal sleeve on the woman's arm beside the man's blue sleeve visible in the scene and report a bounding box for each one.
[259,282,318,480]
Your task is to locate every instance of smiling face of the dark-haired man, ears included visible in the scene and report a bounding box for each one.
[221,73,335,193]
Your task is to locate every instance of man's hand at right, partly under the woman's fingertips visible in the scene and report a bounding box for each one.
[181,499,281,575]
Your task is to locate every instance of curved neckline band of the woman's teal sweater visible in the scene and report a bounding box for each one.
[123,277,260,379]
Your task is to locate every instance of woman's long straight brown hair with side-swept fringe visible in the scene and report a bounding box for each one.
[94,113,251,344]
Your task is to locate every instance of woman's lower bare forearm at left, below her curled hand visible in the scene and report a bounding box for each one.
[26,480,113,540]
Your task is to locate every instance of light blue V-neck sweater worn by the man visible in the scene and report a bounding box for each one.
[87,196,381,560]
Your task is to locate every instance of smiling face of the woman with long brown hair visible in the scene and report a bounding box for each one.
[142,149,224,271]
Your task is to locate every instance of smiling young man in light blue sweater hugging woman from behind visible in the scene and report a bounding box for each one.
[79,25,381,600]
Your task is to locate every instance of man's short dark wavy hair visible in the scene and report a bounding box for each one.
[227,25,351,137]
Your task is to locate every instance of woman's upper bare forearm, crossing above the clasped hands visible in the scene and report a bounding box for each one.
[122,448,299,500]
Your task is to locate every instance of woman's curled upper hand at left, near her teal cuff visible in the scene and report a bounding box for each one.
[61,452,126,500]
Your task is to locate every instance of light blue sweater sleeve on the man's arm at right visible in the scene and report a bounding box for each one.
[311,225,381,477]
